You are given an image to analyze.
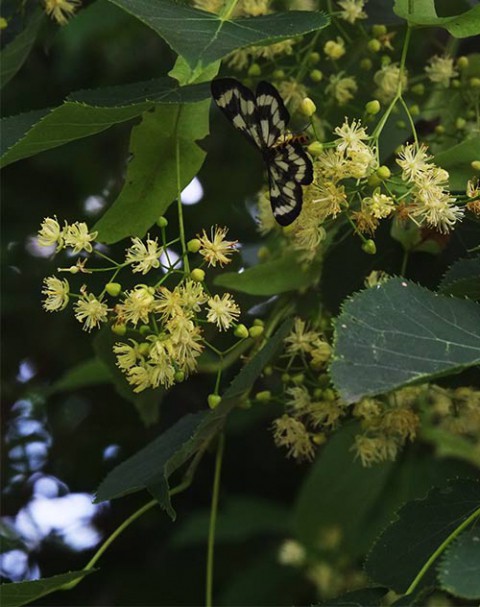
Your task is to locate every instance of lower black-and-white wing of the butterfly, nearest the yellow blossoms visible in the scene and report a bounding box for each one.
[264,142,313,226]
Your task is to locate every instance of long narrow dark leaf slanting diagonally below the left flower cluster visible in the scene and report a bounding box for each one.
[95,321,289,519]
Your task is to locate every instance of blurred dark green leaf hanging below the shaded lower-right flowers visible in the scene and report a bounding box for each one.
[295,424,394,557]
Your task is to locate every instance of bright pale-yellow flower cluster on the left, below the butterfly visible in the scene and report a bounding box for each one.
[38,217,248,392]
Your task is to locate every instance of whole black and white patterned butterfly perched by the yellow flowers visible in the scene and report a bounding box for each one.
[212,78,313,226]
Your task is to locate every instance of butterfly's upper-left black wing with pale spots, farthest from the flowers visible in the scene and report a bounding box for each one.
[211,78,265,150]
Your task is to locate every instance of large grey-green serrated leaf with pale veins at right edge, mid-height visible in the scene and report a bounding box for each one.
[330,278,480,403]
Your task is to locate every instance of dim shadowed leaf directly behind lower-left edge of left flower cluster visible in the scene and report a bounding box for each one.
[93,327,165,427]
